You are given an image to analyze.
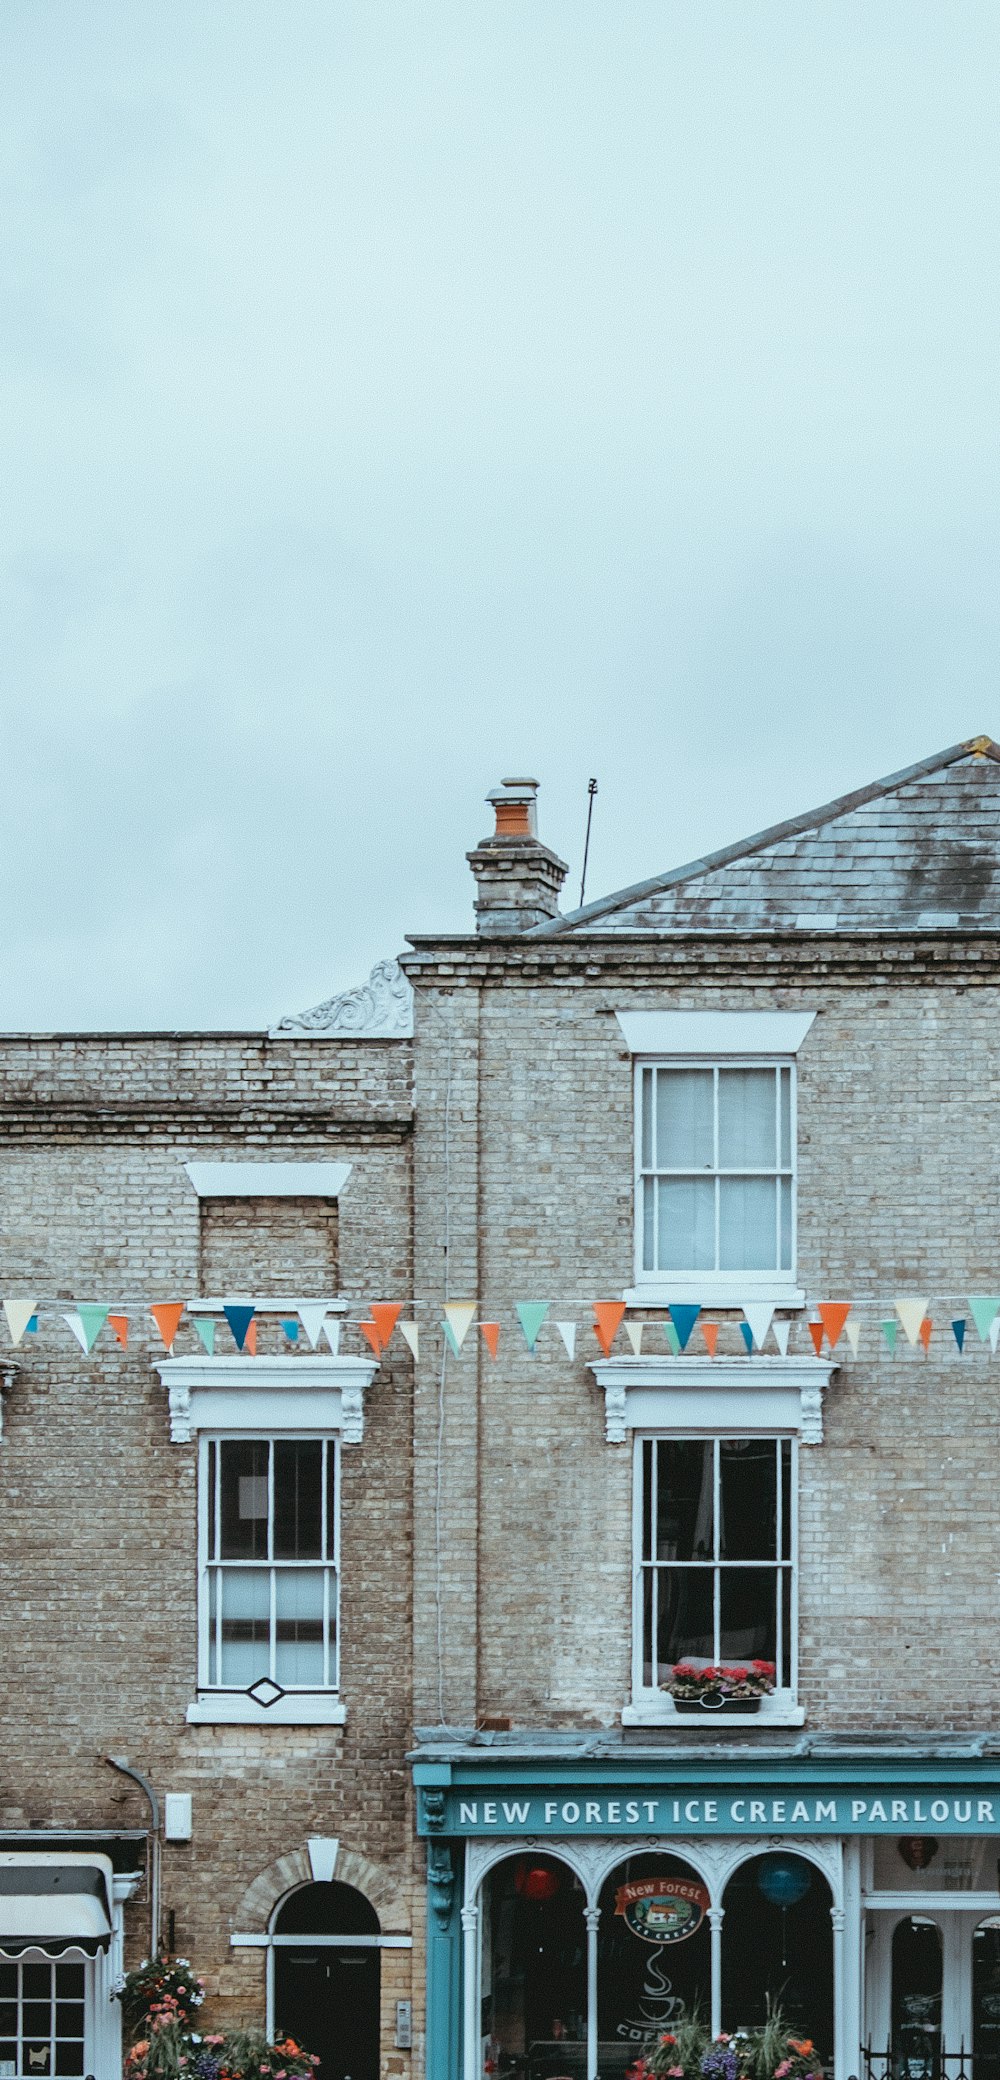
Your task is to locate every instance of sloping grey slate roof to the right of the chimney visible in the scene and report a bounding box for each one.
[526,736,1000,938]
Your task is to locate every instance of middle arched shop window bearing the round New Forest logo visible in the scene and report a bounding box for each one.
[597,1851,711,2074]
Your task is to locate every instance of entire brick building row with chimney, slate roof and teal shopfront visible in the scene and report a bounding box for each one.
[0,738,1000,2080]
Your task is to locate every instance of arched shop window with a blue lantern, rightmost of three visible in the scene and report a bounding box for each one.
[721,1851,834,2061]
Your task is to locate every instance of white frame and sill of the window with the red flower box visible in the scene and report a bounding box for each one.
[622,1425,805,1735]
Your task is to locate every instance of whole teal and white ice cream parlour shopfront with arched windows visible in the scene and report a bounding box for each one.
[414,1747,1000,2080]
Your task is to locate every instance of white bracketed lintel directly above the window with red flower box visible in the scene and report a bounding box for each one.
[590,1356,838,1444]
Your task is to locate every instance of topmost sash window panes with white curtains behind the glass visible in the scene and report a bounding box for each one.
[636,1061,794,1272]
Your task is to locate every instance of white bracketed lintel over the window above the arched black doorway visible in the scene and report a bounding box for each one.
[156,1352,378,1444]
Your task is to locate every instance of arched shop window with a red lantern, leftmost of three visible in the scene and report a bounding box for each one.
[480,1853,586,2080]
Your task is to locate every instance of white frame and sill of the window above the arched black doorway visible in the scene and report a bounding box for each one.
[187,1429,347,1726]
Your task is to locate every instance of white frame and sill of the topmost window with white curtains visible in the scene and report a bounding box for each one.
[624,1052,805,1306]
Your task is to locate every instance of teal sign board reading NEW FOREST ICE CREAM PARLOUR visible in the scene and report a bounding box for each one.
[420,1783,1000,1837]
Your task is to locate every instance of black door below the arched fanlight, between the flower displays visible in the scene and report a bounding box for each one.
[274,1936,380,2080]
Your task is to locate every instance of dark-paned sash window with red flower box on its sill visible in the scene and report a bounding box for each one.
[634,1437,798,1697]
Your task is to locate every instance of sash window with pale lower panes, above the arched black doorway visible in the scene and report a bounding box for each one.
[200,1437,339,1704]
